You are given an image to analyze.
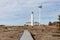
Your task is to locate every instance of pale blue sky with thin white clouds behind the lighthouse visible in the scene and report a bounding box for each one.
[0,0,60,25]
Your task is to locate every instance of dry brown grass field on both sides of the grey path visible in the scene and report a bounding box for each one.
[0,26,60,40]
